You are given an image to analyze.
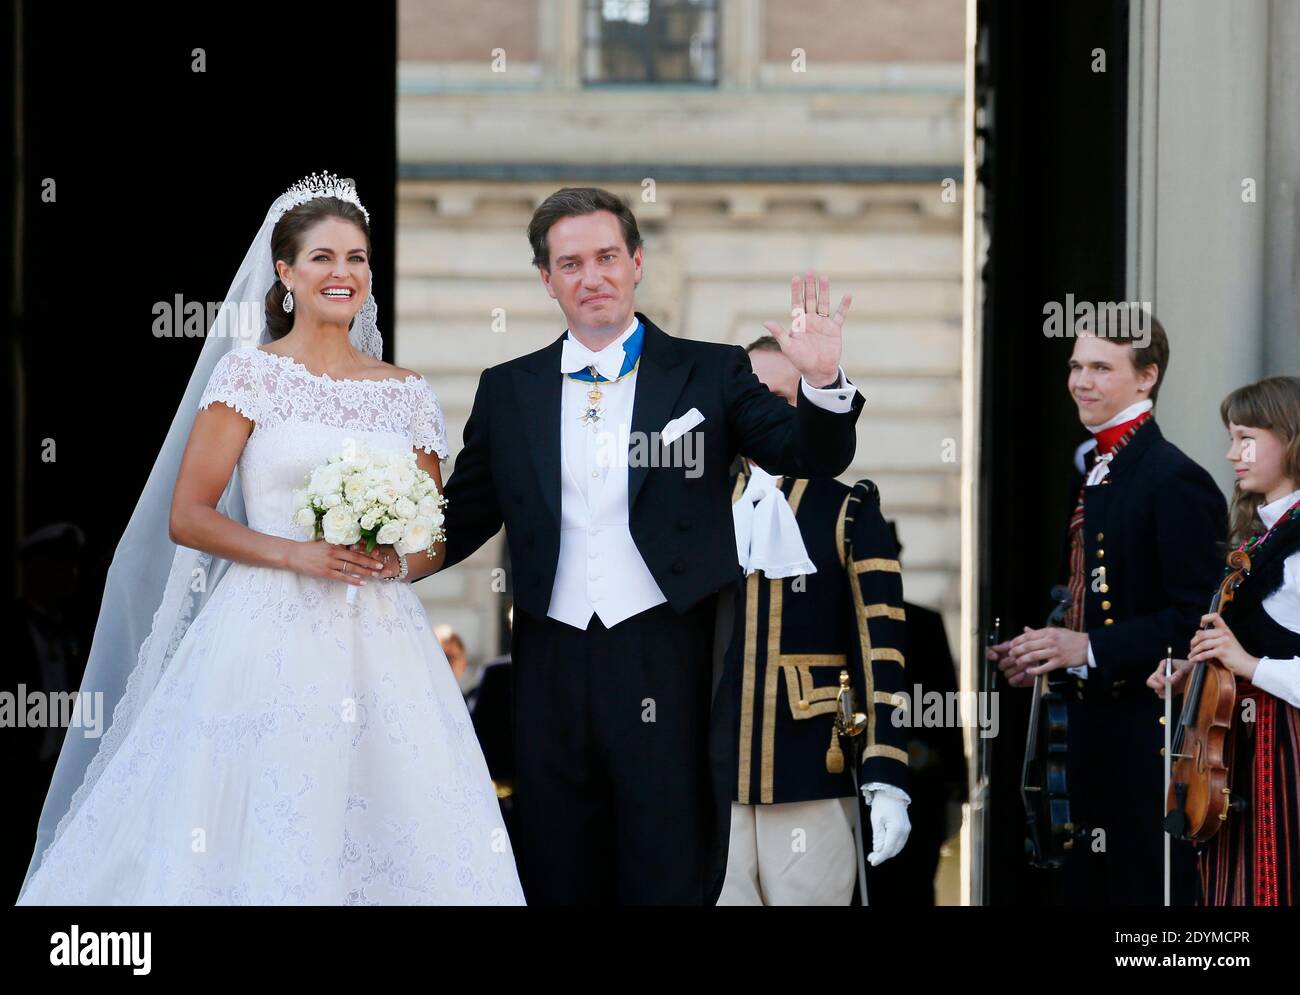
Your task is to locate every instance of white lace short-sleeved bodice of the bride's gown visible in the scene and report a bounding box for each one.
[199,346,449,538]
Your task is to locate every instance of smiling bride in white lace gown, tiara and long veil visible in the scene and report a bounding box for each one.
[18,173,523,905]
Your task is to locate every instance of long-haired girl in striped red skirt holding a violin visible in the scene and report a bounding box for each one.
[1147,377,1300,905]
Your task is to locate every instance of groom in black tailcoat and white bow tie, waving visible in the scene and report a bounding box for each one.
[443,187,863,904]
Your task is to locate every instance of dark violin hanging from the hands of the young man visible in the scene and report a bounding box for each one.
[1021,585,1087,869]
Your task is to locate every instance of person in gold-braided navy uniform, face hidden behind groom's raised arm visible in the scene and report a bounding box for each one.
[714,337,910,905]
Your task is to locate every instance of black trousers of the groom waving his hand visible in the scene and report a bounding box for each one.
[512,597,716,905]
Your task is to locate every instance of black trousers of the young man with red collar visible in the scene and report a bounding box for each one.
[1061,688,1197,905]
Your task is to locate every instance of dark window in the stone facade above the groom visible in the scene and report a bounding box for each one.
[582,0,718,86]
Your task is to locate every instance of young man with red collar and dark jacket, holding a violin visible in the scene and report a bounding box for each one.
[989,311,1226,905]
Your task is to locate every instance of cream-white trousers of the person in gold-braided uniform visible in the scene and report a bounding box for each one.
[718,799,858,905]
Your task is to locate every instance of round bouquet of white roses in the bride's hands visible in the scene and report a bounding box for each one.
[294,438,447,605]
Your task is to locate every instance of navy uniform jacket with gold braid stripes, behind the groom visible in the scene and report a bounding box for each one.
[715,473,909,804]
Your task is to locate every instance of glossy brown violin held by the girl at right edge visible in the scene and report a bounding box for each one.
[1165,549,1251,843]
